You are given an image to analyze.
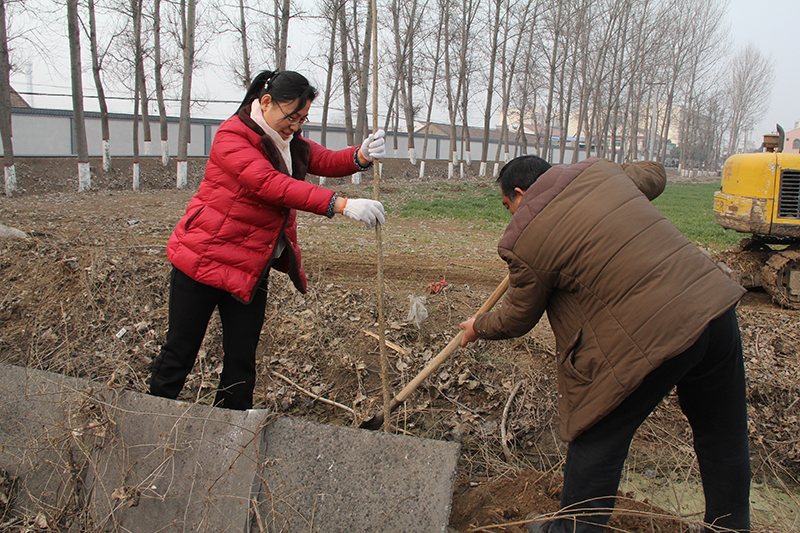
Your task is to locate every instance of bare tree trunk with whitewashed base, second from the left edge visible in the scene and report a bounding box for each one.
[67,0,92,191]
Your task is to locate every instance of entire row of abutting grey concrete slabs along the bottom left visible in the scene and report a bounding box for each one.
[0,365,458,533]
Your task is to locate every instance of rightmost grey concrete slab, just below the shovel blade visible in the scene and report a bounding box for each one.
[256,418,459,533]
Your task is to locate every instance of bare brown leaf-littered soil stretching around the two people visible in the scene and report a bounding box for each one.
[0,157,800,533]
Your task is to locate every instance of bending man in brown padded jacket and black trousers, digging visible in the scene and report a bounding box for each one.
[461,156,750,533]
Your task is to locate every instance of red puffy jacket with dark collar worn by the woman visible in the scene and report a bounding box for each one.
[167,106,358,302]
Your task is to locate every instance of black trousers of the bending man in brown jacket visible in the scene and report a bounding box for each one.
[545,308,750,533]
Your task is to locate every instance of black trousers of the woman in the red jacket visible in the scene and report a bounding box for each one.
[145,267,267,410]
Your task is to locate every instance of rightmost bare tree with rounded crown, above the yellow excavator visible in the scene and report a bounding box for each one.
[725,43,775,154]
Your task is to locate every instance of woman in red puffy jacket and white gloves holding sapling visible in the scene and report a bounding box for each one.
[150,71,385,409]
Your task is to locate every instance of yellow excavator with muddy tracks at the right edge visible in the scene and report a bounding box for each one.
[714,125,800,309]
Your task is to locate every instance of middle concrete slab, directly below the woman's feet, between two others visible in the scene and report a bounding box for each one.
[87,391,268,532]
